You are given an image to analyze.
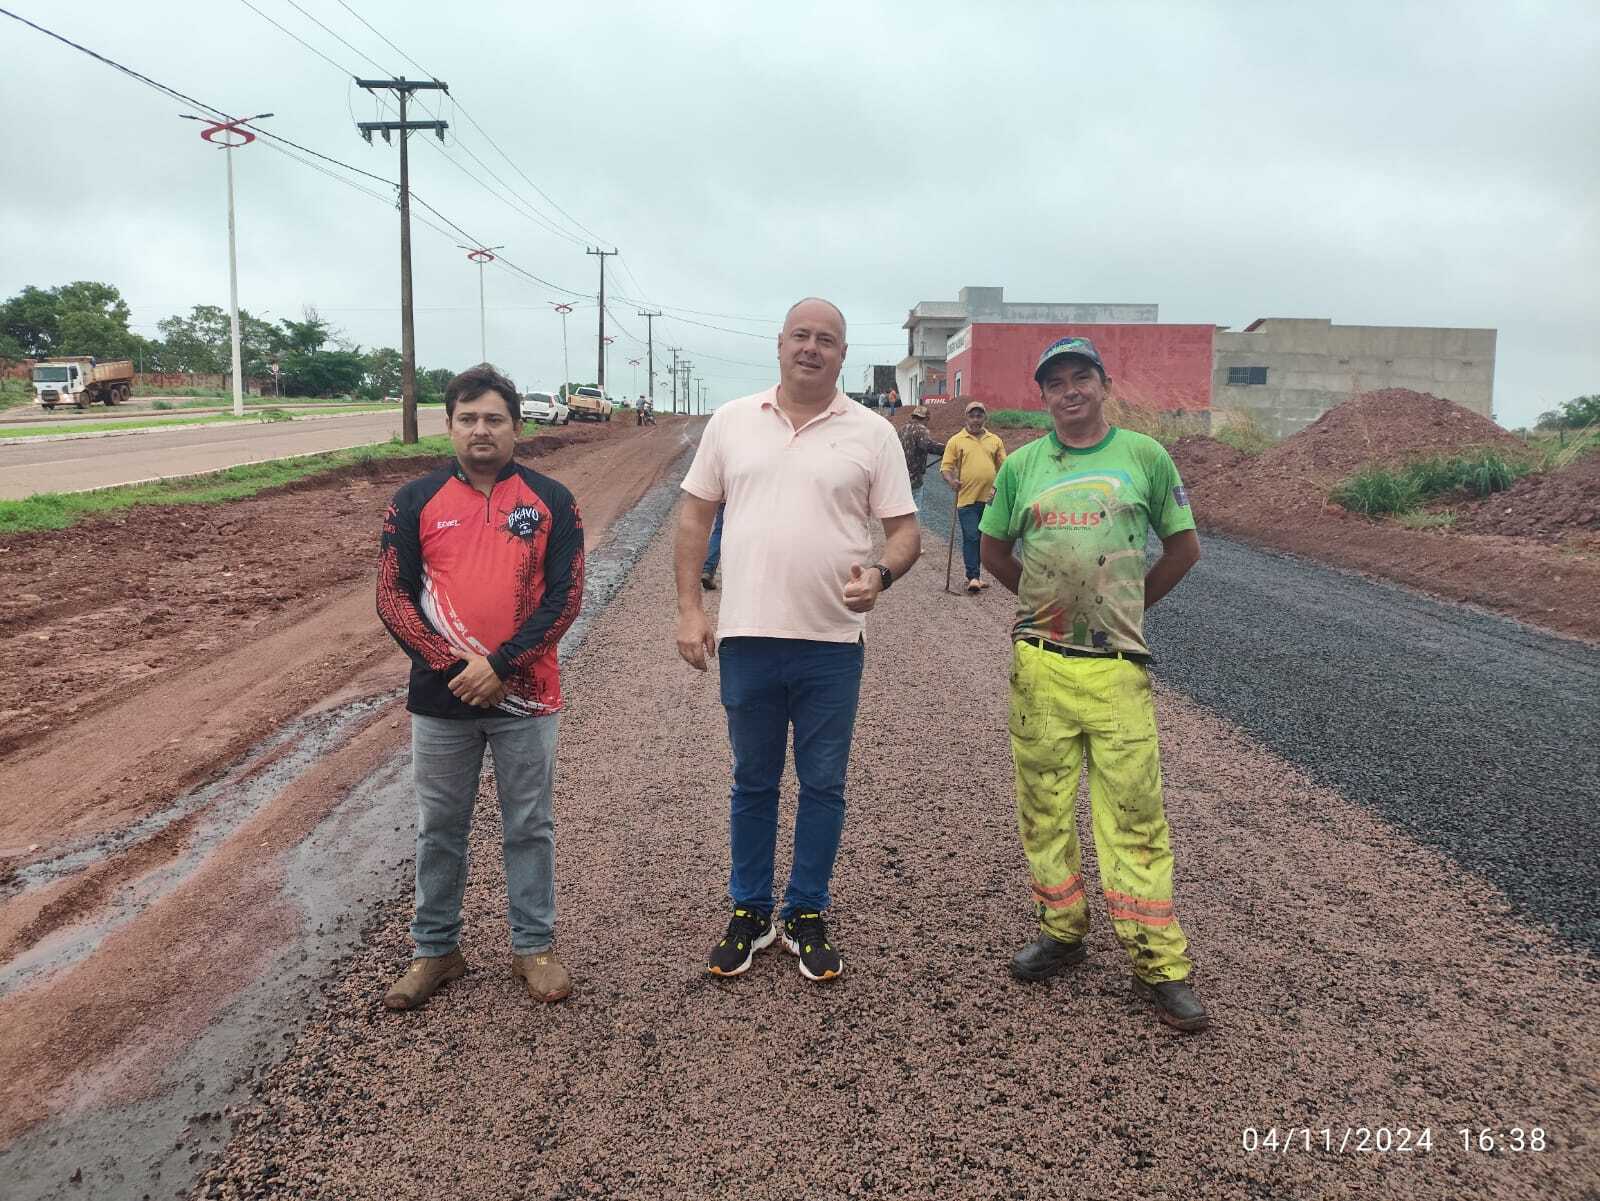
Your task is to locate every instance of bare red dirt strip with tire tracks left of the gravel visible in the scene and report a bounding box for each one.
[0,421,700,1147]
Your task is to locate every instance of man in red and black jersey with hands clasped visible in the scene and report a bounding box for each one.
[378,363,584,1009]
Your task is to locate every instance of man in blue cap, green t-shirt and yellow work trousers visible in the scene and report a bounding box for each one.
[979,337,1206,1031]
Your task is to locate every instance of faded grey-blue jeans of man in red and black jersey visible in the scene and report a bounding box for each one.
[411,713,560,960]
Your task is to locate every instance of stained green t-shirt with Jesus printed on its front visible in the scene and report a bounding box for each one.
[978,427,1195,654]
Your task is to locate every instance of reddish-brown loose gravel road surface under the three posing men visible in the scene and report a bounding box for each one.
[198,492,1600,1198]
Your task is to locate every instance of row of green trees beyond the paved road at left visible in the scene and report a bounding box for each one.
[0,280,454,401]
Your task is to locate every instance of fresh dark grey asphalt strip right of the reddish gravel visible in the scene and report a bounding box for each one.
[922,472,1600,950]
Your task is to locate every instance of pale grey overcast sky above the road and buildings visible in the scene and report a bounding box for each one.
[0,0,1600,425]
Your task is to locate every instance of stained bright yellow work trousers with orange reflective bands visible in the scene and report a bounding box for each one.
[1010,643,1194,984]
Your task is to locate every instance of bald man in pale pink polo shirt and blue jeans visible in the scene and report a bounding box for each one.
[675,297,922,980]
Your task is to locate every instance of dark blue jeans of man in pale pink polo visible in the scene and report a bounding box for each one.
[718,638,866,918]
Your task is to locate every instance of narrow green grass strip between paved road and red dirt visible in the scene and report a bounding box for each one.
[0,435,453,537]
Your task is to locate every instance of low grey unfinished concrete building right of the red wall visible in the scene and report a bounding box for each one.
[1211,317,1496,438]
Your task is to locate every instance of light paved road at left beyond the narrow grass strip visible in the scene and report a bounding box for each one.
[0,408,432,501]
